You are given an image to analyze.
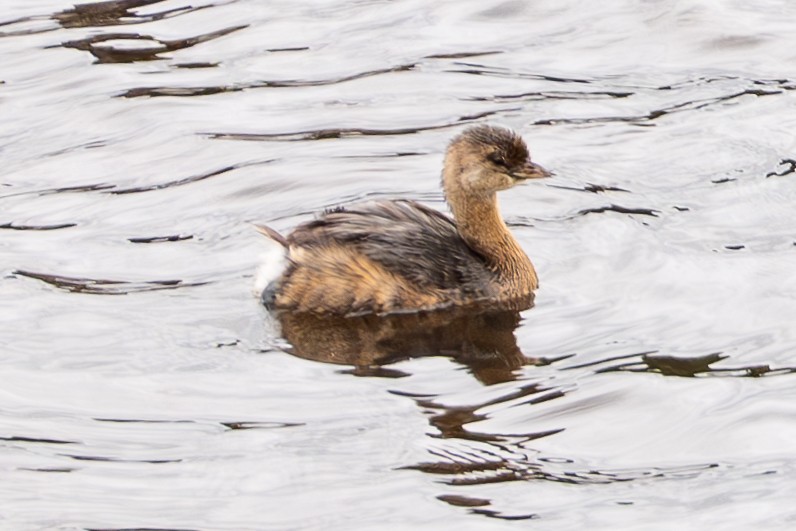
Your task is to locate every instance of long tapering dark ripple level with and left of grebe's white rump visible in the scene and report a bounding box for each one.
[13,269,209,295]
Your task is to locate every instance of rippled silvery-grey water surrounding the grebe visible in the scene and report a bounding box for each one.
[0,0,796,530]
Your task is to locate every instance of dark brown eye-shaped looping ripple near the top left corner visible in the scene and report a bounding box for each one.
[61,25,248,63]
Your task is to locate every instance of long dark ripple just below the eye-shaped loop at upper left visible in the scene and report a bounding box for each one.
[117,63,417,98]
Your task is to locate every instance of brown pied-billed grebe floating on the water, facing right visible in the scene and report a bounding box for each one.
[257,125,549,315]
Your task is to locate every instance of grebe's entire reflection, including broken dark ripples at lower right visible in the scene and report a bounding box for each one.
[268,300,748,520]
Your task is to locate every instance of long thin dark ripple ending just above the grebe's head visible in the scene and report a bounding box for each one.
[204,109,518,141]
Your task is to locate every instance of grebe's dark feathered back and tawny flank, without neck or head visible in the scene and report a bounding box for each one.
[265,201,497,314]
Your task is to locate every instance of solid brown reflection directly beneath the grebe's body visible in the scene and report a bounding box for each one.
[276,298,540,385]
